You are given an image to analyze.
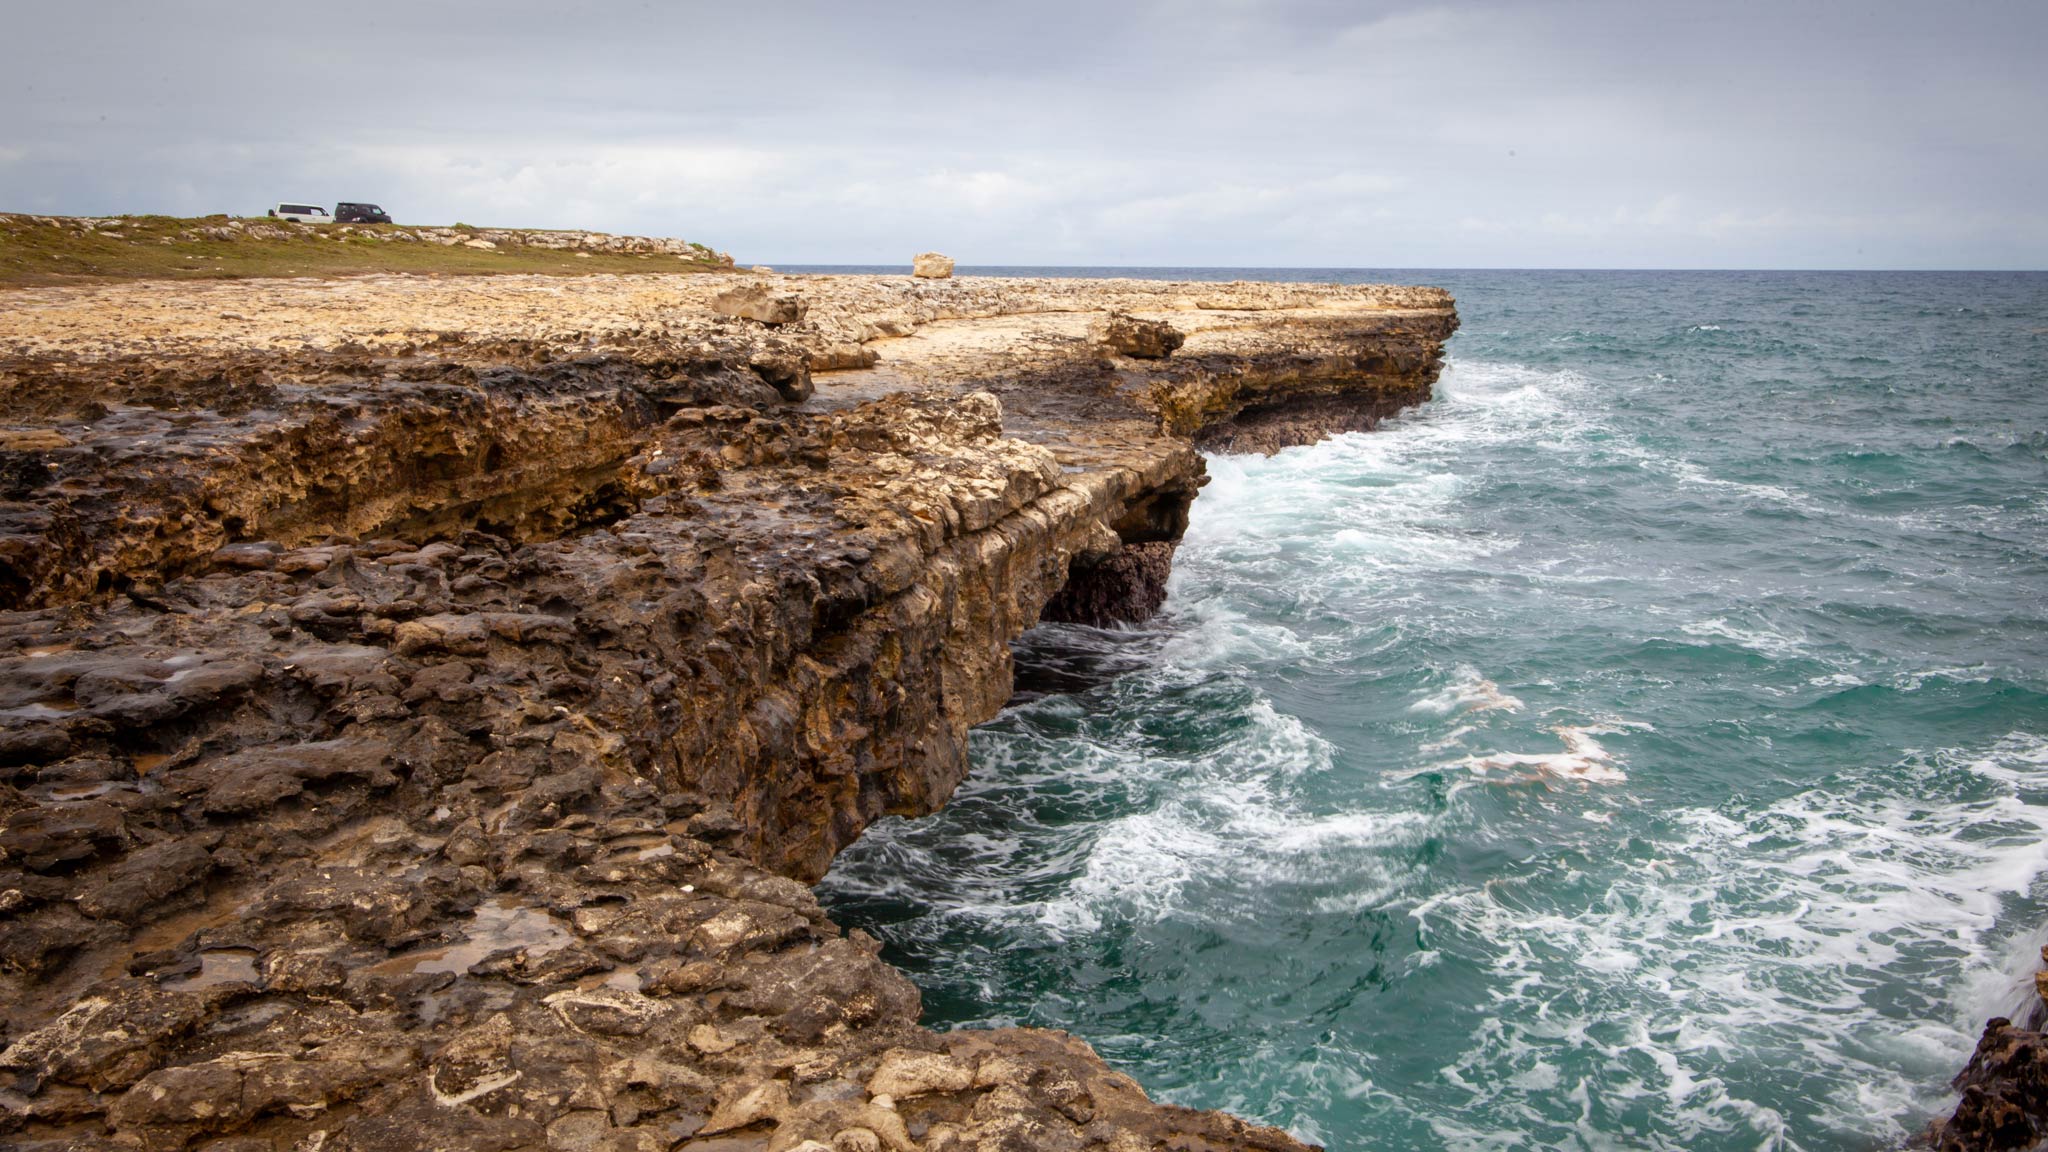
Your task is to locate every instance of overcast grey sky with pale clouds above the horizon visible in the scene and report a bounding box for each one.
[0,0,2048,269]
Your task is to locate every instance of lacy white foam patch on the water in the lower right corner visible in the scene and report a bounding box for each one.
[1413,734,2048,1148]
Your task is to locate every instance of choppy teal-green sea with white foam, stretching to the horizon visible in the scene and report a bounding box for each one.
[823,271,2048,1150]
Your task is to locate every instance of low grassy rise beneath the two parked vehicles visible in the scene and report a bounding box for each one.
[0,213,731,287]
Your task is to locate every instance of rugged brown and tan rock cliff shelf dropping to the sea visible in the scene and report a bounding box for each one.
[0,277,1456,1152]
